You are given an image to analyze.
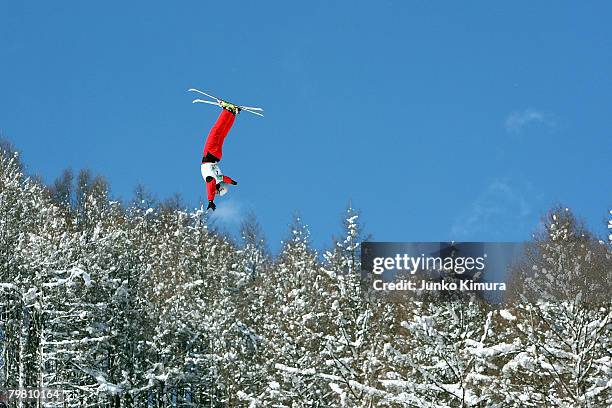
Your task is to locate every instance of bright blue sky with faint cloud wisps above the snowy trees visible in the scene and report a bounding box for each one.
[0,1,612,252]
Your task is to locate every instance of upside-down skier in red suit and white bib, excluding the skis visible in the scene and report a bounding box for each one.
[201,101,241,211]
